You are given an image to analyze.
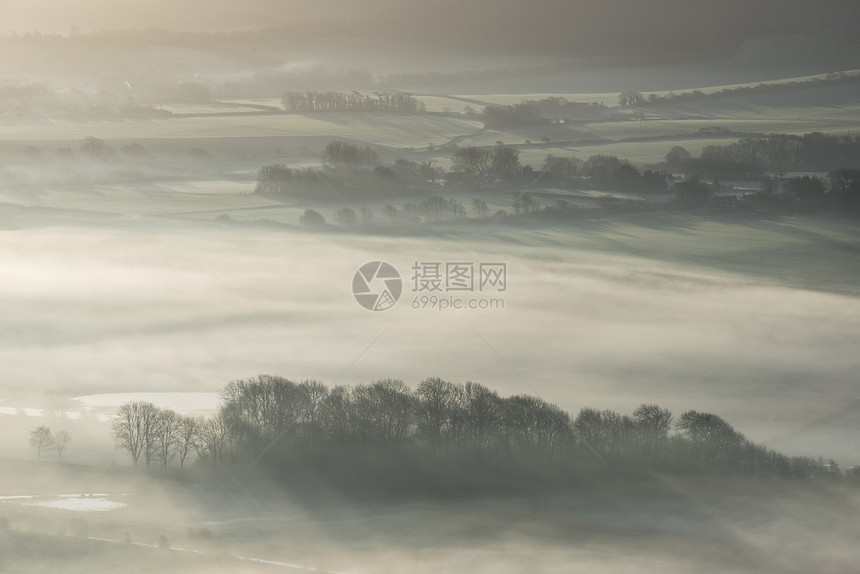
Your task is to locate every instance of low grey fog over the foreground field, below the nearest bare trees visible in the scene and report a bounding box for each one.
[0,462,857,573]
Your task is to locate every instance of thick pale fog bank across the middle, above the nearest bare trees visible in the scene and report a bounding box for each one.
[0,215,860,463]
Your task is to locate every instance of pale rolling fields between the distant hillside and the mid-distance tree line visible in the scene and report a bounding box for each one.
[0,67,860,170]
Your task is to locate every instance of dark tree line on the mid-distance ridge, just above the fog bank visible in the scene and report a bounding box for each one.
[256,137,860,216]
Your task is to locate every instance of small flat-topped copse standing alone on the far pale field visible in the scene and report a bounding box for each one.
[281,90,426,114]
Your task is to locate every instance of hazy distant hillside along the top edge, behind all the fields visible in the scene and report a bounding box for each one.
[0,0,860,68]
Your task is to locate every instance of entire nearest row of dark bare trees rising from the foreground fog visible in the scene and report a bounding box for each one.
[113,375,843,492]
